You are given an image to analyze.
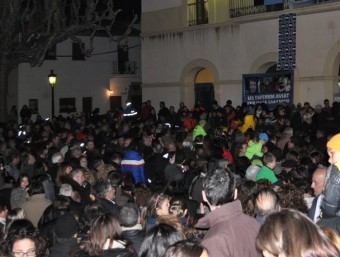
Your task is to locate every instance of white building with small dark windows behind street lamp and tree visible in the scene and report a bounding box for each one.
[8,36,141,120]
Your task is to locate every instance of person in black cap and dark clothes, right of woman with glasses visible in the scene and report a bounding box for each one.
[50,213,79,257]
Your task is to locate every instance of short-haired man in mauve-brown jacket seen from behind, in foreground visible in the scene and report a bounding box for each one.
[196,169,261,257]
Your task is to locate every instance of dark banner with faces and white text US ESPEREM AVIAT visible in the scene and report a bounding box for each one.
[242,71,294,109]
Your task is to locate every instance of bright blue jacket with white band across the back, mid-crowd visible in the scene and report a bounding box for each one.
[121,150,146,184]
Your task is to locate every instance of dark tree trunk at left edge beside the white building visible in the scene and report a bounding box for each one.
[0,53,9,123]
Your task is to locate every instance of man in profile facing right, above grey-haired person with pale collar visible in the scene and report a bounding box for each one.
[93,178,119,219]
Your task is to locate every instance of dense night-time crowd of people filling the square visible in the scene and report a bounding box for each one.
[0,99,340,254]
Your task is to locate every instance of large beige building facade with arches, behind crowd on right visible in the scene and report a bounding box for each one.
[141,0,340,107]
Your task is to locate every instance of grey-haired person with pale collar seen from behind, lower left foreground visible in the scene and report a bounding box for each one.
[120,203,145,252]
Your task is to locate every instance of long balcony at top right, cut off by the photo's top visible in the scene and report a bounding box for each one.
[230,0,339,18]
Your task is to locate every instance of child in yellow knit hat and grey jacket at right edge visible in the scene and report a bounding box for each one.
[319,133,340,233]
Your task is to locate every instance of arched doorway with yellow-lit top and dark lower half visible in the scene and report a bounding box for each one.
[195,68,215,109]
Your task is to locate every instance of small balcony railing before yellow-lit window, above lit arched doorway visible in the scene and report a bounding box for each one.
[188,0,209,26]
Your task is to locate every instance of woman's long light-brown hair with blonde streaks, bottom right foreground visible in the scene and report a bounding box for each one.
[256,209,340,257]
